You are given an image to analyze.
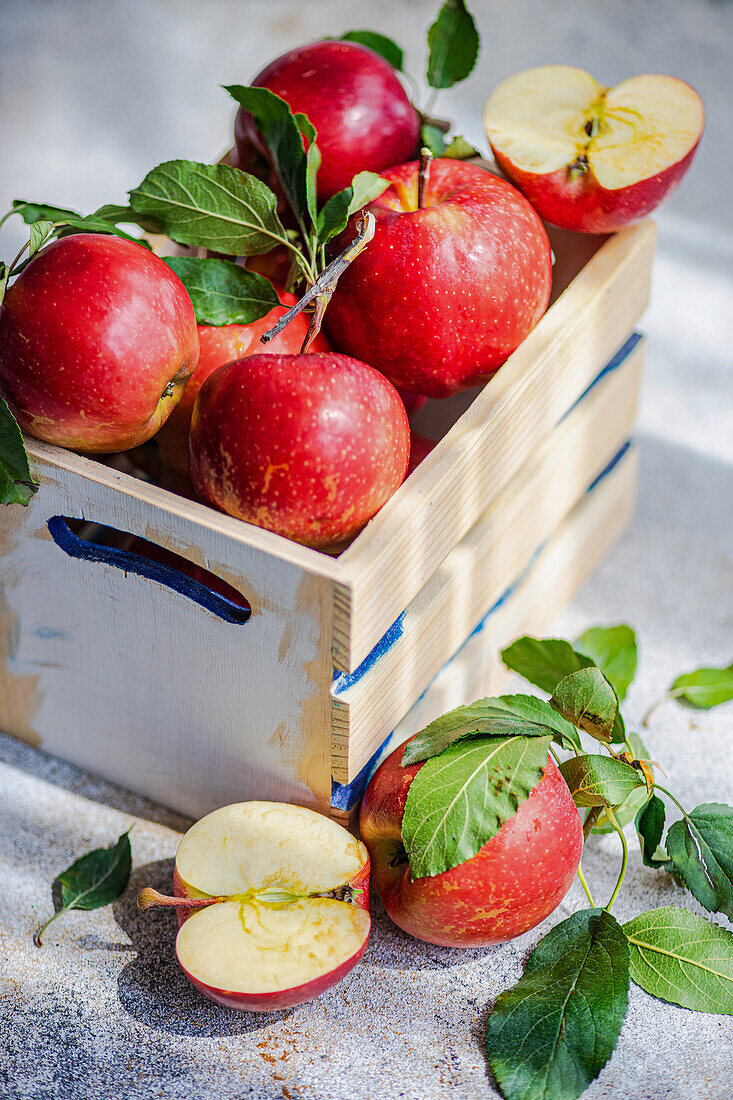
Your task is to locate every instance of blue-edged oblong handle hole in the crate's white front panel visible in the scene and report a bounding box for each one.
[48,516,252,624]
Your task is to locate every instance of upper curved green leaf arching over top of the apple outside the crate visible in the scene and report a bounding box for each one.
[402,695,578,768]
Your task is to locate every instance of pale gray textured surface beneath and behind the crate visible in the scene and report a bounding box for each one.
[0,0,733,1100]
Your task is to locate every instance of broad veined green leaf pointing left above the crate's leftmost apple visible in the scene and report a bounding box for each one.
[130,159,286,256]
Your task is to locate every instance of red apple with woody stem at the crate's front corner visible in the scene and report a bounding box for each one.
[189,352,409,548]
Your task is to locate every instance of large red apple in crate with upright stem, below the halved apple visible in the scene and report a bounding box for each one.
[325,160,553,397]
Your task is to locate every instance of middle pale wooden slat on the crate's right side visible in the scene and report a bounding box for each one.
[332,343,643,782]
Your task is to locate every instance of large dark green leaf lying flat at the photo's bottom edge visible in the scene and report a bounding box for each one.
[486,909,628,1100]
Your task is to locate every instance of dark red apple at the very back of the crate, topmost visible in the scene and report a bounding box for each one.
[234,41,419,202]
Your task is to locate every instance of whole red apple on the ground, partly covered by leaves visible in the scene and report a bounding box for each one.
[359,746,583,947]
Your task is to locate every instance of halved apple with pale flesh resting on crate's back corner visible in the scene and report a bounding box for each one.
[483,65,704,233]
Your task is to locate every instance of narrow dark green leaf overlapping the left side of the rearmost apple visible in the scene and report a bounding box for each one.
[225,84,315,221]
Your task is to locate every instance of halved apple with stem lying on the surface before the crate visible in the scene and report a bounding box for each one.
[139,802,371,1012]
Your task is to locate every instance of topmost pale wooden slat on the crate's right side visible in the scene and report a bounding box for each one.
[333,222,656,671]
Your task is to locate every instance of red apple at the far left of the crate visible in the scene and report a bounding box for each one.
[0,233,198,452]
